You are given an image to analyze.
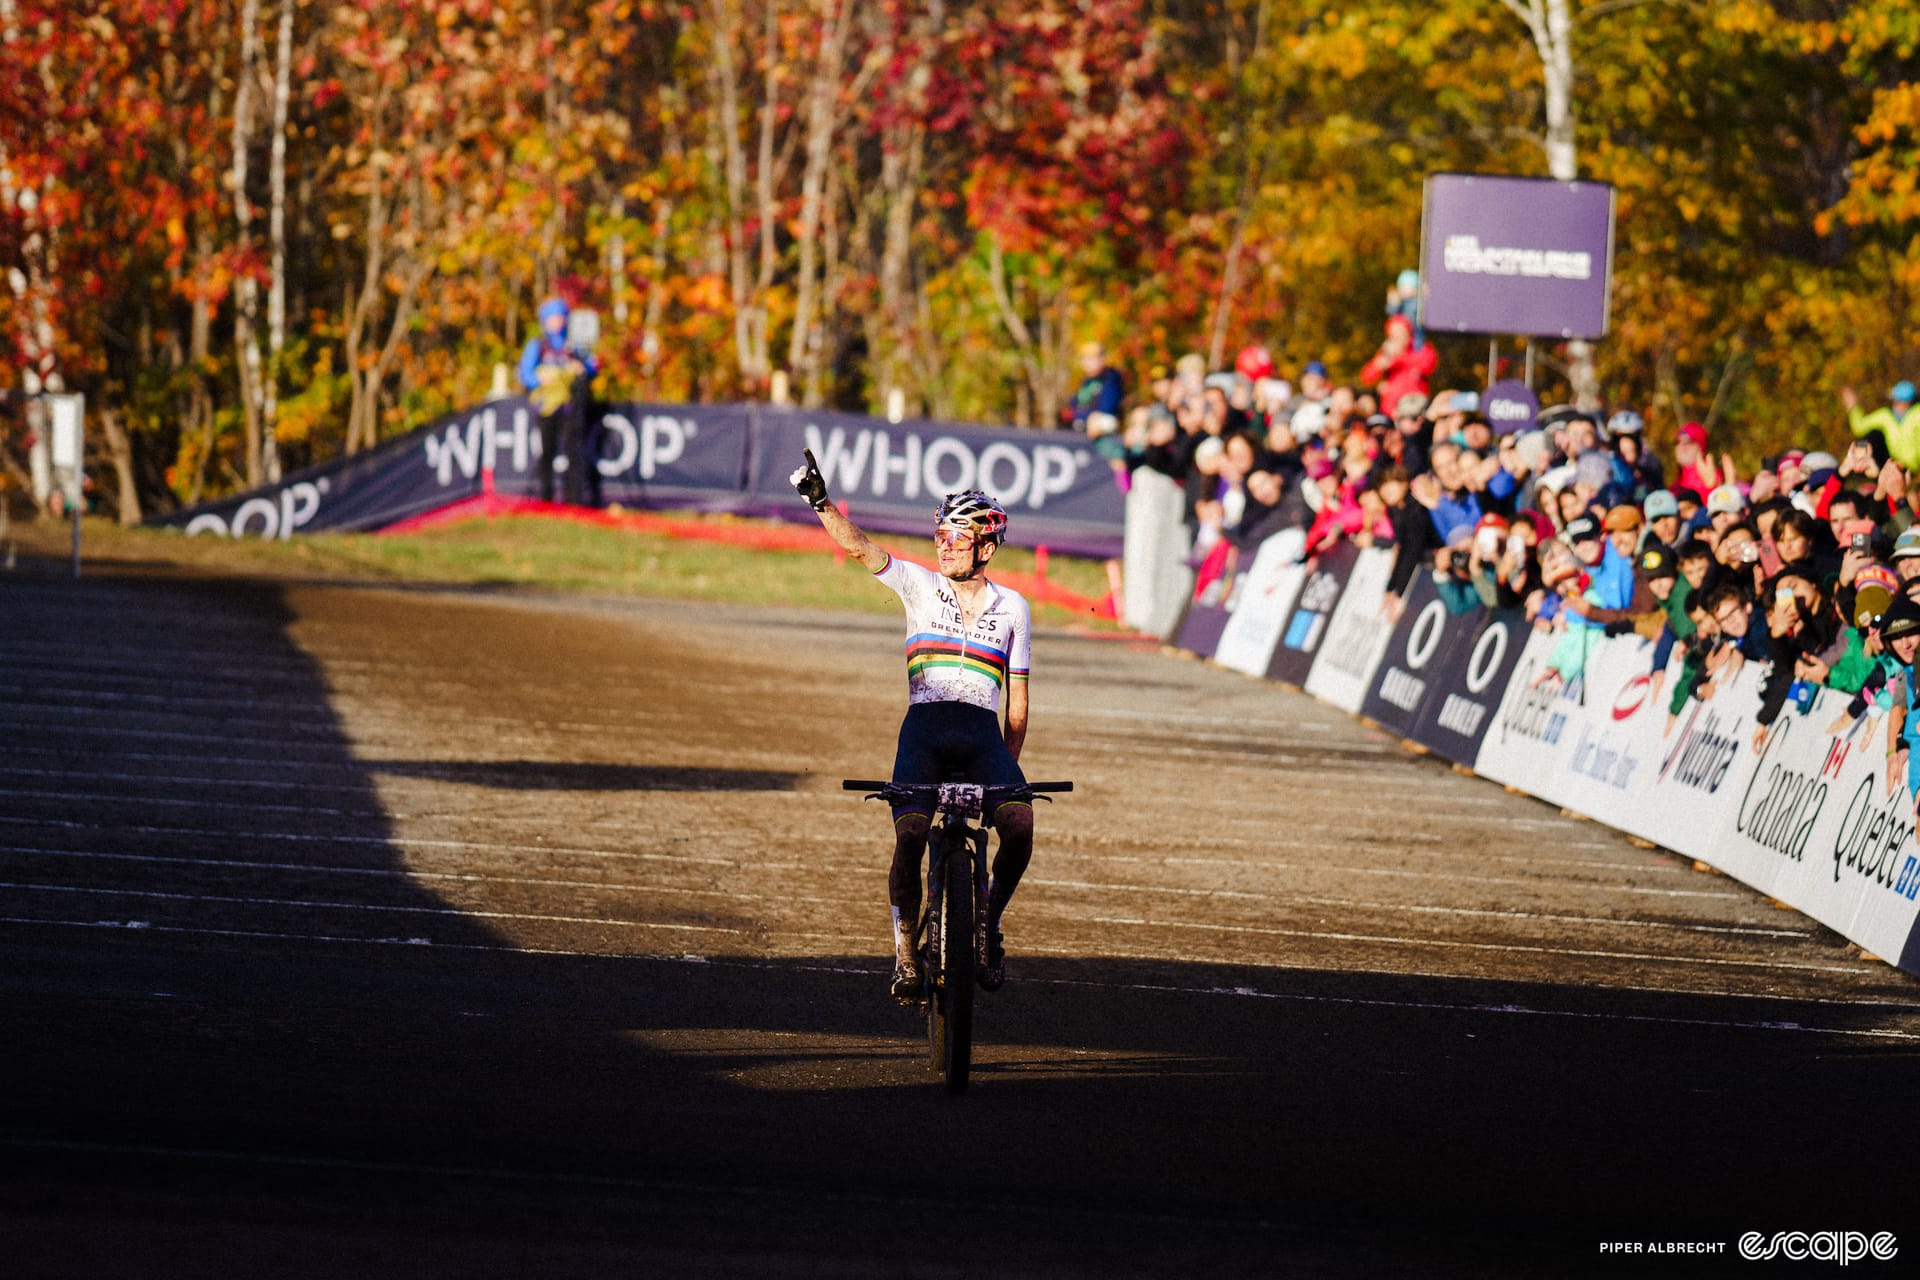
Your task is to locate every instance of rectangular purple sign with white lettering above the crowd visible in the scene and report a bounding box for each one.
[1421,173,1613,338]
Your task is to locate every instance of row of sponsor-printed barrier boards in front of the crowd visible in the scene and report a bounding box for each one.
[1183,549,1920,973]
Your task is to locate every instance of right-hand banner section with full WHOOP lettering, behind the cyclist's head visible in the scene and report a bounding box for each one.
[747,409,1125,557]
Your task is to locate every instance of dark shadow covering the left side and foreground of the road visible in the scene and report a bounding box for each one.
[0,564,1916,1276]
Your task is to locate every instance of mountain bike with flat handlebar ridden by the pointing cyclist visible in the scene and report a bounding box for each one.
[841,777,1073,1096]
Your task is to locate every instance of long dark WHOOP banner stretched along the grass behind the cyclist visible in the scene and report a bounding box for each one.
[161,399,1125,557]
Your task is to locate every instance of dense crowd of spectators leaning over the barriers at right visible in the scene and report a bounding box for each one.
[1071,311,1920,791]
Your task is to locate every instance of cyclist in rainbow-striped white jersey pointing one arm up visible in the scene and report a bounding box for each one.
[791,451,1033,1002]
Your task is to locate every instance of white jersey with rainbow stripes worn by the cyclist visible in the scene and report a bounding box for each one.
[874,555,1033,714]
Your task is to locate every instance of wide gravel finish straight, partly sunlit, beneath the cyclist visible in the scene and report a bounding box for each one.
[0,564,1920,1276]
